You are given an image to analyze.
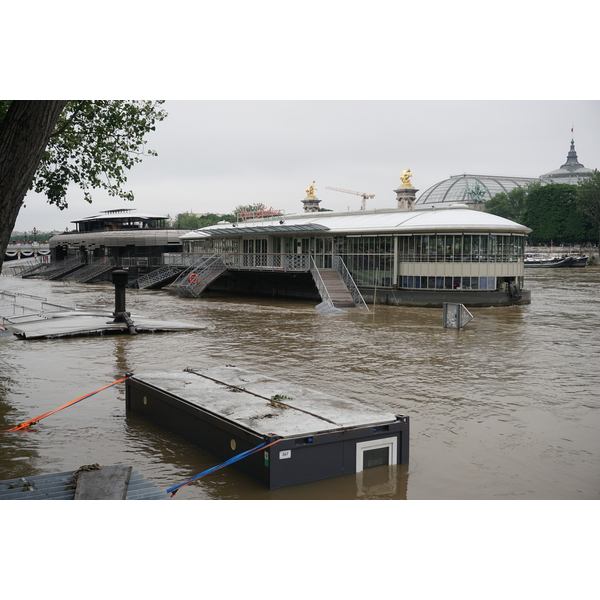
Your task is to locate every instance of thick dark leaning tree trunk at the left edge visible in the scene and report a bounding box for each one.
[0,100,67,269]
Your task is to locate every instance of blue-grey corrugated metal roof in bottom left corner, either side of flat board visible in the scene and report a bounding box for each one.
[0,471,169,500]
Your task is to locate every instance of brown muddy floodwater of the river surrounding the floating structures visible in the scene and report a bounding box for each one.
[0,267,600,500]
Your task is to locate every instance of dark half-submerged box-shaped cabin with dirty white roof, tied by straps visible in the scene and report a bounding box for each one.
[126,366,409,489]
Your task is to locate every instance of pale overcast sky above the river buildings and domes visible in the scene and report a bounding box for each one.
[16,100,600,231]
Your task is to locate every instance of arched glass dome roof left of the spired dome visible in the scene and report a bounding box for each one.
[415,173,539,206]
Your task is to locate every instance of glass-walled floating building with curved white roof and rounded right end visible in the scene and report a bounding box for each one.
[182,204,530,306]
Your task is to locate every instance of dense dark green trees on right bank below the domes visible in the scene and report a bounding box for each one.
[484,170,600,245]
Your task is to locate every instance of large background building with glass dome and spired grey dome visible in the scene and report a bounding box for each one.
[415,140,593,210]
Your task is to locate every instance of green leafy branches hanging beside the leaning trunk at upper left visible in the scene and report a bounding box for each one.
[29,100,167,210]
